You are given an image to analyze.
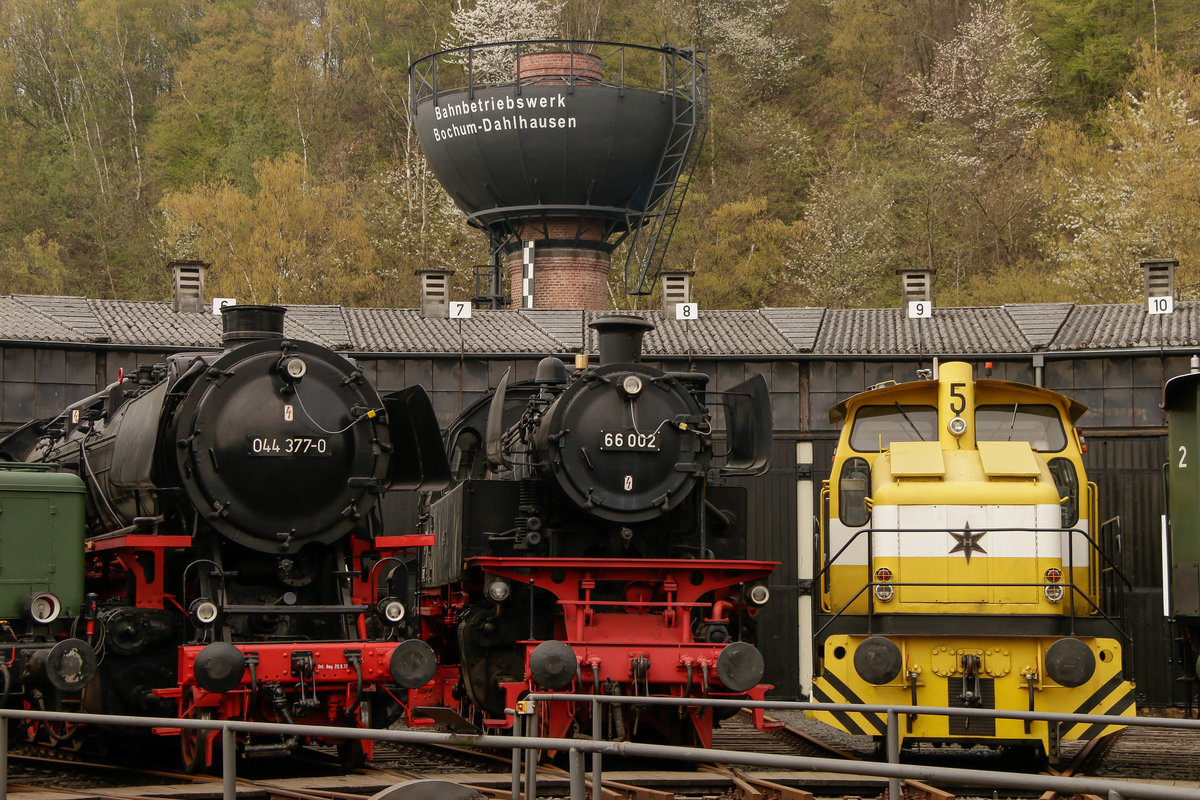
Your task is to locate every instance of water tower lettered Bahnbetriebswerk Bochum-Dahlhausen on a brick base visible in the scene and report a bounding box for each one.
[408,41,708,309]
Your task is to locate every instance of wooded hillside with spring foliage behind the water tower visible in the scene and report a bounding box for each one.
[0,0,1200,308]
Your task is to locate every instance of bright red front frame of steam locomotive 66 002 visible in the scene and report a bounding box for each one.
[409,557,778,747]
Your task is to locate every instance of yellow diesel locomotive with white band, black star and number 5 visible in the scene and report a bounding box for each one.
[812,362,1136,760]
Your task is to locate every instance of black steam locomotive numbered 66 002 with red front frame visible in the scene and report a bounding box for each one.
[410,317,775,746]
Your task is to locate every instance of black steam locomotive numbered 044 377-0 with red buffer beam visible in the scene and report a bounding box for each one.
[0,306,449,769]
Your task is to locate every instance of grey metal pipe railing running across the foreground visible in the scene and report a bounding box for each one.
[0,693,1200,800]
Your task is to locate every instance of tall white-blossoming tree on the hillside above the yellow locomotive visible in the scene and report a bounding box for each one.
[894,1,1048,302]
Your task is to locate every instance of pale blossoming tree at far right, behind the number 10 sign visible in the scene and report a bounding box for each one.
[1040,53,1200,302]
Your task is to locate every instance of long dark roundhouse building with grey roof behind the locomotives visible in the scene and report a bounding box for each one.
[0,287,1200,706]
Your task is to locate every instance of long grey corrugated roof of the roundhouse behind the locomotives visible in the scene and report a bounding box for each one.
[7,295,1200,357]
